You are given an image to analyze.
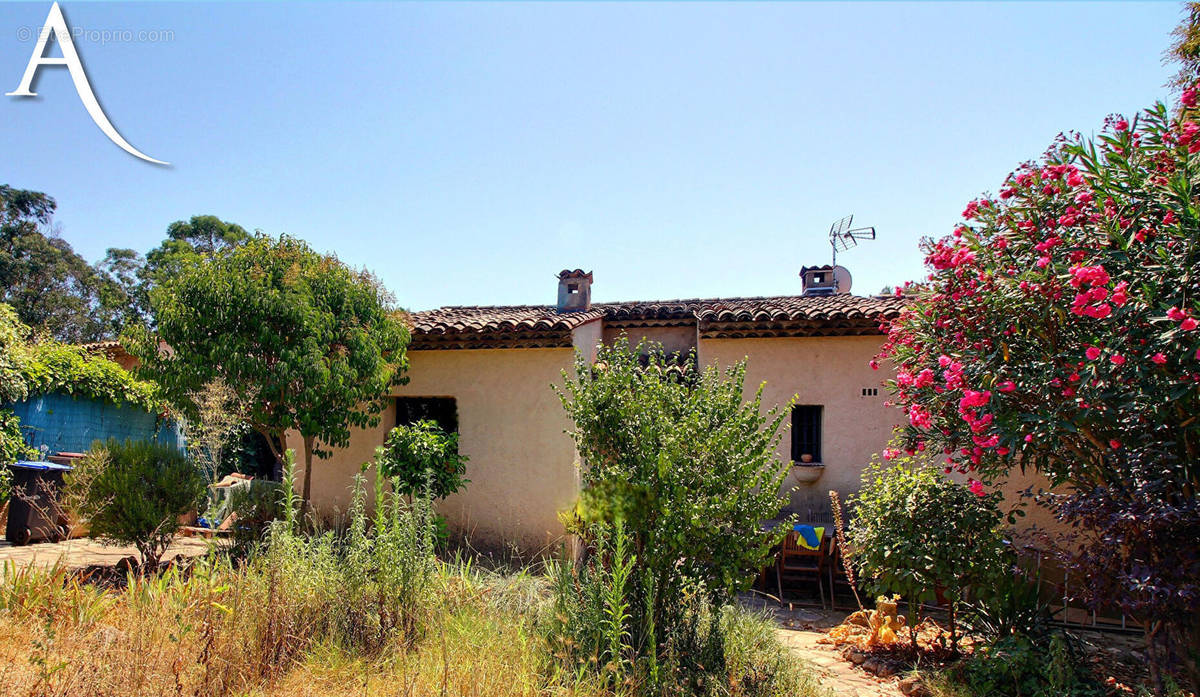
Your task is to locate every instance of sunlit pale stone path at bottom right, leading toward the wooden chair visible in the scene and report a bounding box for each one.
[742,597,902,697]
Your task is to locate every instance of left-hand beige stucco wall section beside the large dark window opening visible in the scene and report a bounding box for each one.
[297,345,583,552]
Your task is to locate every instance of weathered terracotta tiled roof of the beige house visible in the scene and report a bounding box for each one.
[412,295,905,348]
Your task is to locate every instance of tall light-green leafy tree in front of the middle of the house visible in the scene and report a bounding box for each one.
[558,341,787,673]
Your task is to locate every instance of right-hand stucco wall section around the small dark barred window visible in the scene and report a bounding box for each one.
[698,336,904,519]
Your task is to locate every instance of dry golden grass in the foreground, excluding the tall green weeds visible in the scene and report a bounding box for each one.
[0,558,809,697]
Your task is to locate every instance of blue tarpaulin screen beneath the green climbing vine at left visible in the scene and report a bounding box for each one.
[7,393,184,453]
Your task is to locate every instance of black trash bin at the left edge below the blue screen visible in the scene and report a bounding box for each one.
[5,461,72,545]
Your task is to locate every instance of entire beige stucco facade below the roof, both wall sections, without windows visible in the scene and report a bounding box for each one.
[300,311,900,553]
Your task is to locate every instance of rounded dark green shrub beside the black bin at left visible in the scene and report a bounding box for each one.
[66,439,206,566]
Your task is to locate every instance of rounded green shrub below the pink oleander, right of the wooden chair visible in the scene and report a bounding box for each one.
[848,448,1006,643]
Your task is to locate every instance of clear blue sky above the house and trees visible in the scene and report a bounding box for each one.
[0,0,1181,310]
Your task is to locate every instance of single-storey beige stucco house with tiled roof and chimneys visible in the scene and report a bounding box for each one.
[295,266,902,551]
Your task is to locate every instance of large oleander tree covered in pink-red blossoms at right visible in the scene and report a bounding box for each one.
[882,97,1200,690]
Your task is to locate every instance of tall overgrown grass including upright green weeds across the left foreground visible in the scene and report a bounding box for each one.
[0,463,811,697]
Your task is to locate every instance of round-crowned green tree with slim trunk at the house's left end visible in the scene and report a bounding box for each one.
[127,235,408,503]
